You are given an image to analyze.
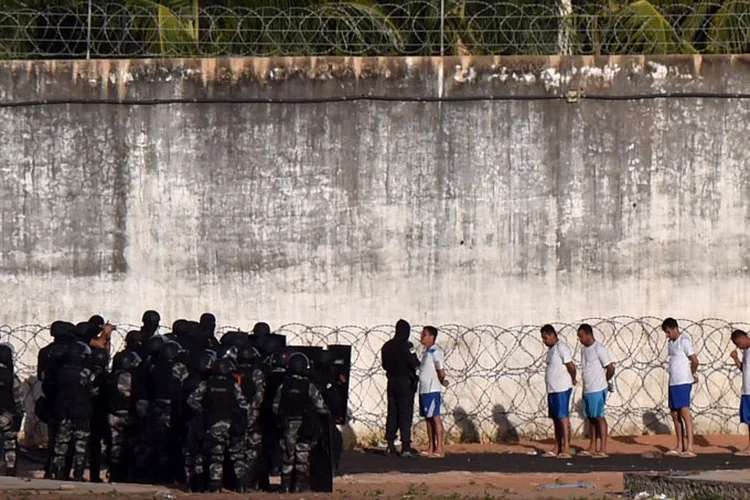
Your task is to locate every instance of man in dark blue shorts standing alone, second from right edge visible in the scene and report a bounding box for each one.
[661,318,698,458]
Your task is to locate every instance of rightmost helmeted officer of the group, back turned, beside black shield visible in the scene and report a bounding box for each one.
[273,352,328,493]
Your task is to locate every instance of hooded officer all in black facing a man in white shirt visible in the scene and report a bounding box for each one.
[381,319,420,457]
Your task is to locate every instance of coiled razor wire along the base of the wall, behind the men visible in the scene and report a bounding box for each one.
[5,316,750,446]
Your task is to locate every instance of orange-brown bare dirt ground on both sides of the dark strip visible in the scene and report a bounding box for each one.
[0,435,750,500]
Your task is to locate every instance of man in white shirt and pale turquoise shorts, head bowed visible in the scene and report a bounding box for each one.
[578,323,615,458]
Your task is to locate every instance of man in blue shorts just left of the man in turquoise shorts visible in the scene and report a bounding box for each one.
[541,325,576,458]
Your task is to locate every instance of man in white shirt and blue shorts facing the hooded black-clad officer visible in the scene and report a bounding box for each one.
[419,326,448,458]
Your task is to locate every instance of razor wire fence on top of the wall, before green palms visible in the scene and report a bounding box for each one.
[0,0,750,59]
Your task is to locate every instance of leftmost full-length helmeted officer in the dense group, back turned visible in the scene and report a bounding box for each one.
[50,342,97,481]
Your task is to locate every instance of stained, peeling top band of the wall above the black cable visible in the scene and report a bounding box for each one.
[0,55,750,103]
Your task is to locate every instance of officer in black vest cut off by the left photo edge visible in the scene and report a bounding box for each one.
[0,345,24,476]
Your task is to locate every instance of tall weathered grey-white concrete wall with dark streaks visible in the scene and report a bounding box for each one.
[0,57,750,442]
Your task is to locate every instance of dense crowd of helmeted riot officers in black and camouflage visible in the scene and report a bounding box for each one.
[32,311,328,492]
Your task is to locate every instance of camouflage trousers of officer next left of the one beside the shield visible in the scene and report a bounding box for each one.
[204,420,248,485]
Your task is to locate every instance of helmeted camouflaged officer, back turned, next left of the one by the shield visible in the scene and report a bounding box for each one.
[187,358,248,492]
